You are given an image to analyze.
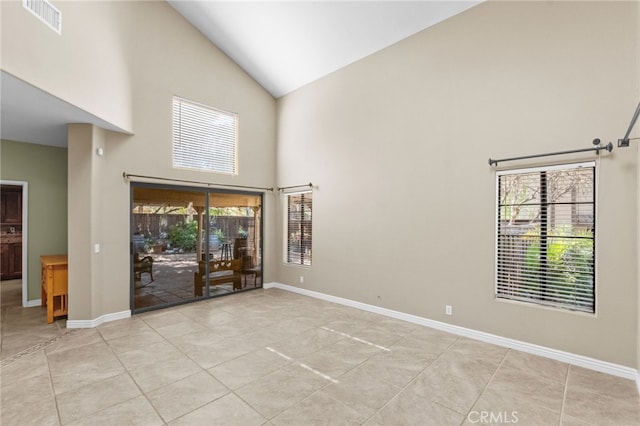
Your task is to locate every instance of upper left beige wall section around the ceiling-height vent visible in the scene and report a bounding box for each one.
[0,0,137,131]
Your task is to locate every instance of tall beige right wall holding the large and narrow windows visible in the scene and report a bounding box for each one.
[276,2,640,368]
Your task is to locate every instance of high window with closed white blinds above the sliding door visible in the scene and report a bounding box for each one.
[173,97,238,175]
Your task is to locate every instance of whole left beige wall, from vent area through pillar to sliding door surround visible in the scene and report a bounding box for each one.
[2,1,276,321]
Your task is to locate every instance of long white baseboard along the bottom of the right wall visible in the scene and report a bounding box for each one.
[272,282,640,382]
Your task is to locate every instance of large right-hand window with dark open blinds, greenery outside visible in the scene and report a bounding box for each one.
[496,163,595,313]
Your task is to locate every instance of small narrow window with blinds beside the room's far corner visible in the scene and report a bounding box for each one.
[286,192,312,266]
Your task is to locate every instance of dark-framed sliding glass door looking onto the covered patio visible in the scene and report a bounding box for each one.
[130,183,262,313]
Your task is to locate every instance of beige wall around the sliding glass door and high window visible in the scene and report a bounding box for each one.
[81,2,276,318]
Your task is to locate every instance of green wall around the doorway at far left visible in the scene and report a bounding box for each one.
[0,140,67,300]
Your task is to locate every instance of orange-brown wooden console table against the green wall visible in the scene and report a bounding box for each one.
[40,254,69,324]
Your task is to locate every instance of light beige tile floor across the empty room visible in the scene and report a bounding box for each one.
[0,282,640,426]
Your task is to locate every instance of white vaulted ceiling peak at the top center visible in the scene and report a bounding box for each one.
[167,0,480,98]
